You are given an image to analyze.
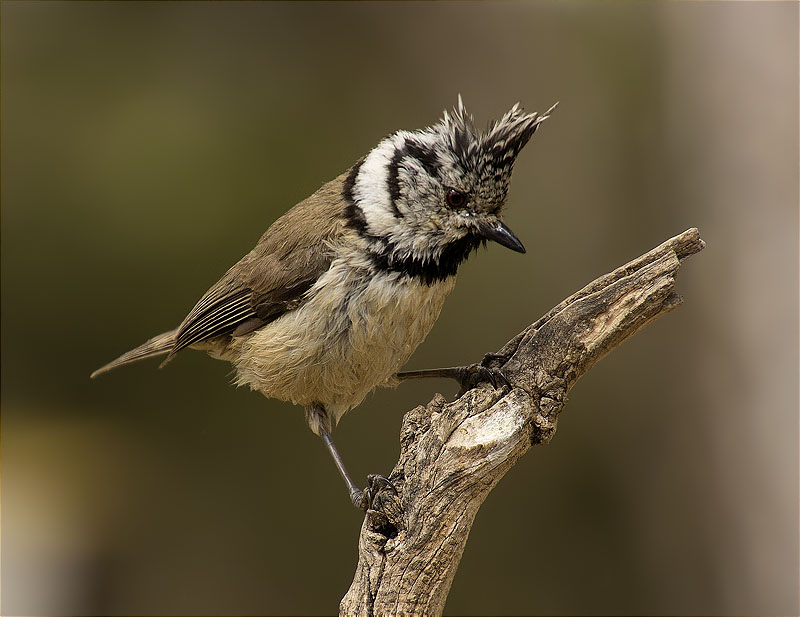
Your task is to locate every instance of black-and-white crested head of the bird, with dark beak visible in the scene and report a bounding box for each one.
[345,96,555,278]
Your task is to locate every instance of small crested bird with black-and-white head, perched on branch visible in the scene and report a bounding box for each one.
[91,95,557,510]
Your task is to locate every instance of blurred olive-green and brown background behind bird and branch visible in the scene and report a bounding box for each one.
[0,1,799,615]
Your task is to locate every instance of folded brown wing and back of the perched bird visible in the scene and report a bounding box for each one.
[164,175,344,364]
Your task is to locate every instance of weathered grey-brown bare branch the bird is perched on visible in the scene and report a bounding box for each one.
[339,229,704,615]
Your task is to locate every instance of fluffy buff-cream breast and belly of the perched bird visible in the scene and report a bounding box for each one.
[223,266,455,422]
